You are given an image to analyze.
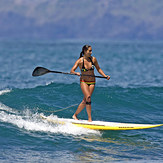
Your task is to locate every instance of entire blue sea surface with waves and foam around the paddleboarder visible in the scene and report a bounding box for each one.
[0,40,163,162]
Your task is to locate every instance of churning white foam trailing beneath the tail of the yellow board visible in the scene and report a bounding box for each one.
[0,110,100,135]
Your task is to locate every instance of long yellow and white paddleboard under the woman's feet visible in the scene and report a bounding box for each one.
[40,115,163,130]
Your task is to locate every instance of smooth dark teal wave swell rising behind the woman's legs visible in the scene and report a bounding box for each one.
[0,83,163,123]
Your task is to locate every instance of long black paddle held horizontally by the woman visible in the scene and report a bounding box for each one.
[32,67,107,79]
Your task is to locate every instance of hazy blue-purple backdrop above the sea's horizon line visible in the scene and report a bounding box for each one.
[0,0,163,40]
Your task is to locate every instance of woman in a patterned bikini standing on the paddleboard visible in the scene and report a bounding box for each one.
[71,45,110,122]
